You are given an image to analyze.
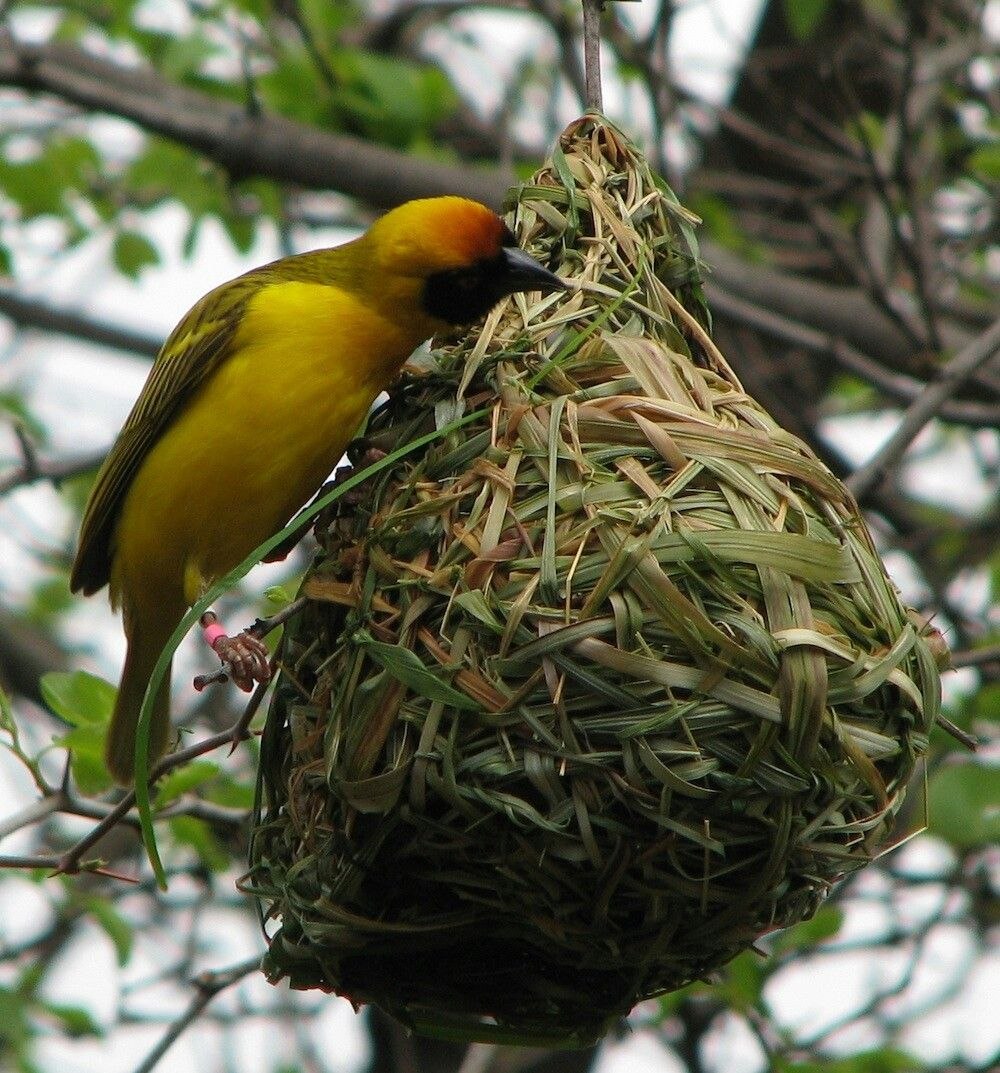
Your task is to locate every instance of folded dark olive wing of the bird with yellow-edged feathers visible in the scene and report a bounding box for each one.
[70,274,254,596]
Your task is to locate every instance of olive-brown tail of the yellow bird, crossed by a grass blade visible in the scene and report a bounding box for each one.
[104,616,176,787]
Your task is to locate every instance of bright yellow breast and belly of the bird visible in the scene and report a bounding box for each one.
[112,282,425,609]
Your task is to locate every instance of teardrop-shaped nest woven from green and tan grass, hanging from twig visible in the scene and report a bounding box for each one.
[246,116,939,1044]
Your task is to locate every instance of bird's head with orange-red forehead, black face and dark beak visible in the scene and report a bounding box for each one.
[365,197,565,324]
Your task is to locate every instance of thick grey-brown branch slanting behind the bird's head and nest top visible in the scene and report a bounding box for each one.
[0,36,970,403]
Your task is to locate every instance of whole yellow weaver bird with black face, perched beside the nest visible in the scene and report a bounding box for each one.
[70,197,564,784]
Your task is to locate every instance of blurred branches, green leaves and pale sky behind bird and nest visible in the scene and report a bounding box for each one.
[0,6,1000,1073]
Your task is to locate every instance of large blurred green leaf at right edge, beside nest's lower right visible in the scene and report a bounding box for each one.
[930,761,1000,849]
